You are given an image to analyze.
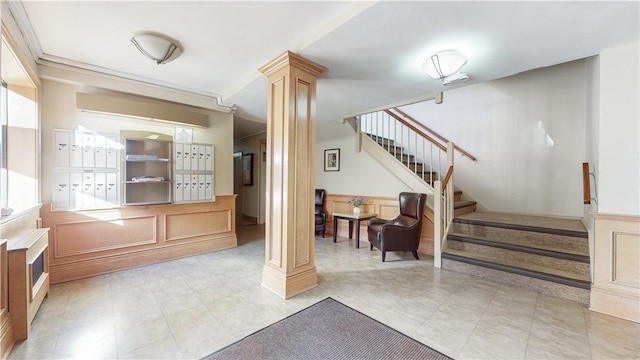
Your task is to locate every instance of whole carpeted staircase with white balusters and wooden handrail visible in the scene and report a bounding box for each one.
[350,99,591,304]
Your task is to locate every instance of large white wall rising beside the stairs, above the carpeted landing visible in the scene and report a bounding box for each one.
[404,60,587,218]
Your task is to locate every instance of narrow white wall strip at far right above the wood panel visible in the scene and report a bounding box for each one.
[597,43,640,215]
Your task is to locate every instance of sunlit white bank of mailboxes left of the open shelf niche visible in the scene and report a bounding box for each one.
[53,130,120,210]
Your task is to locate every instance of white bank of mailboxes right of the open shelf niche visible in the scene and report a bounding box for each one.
[173,143,214,202]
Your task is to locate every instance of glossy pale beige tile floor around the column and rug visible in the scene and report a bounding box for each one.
[9,225,640,359]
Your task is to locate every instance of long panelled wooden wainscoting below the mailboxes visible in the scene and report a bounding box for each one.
[41,195,238,284]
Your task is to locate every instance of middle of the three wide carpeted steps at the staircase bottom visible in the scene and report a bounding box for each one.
[444,236,589,281]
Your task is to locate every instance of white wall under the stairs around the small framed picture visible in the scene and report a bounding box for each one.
[316,119,410,197]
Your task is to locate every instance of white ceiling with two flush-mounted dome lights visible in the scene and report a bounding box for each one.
[11,1,640,138]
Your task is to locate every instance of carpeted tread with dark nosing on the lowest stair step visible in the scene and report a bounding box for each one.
[442,249,591,288]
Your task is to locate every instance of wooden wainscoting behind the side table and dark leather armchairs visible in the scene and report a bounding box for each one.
[325,194,433,255]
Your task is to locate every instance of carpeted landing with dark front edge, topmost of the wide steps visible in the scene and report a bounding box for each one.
[454,211,588,238]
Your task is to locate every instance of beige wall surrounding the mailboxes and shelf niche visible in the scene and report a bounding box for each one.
[40,80,233,203]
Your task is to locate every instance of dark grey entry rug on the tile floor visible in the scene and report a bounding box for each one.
[203,297,451,360]
